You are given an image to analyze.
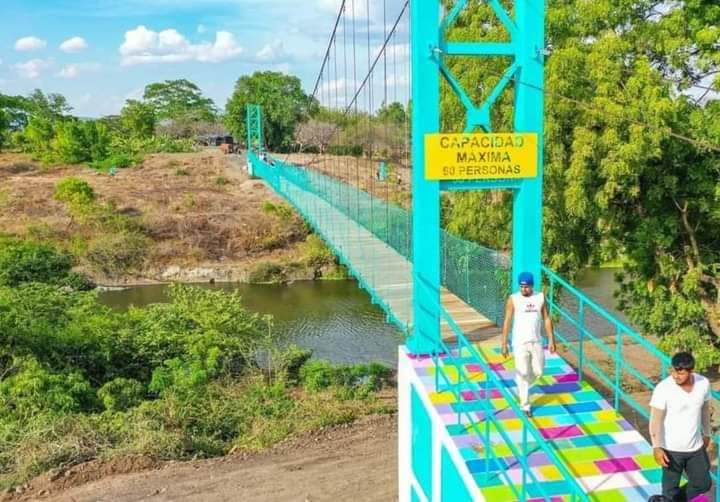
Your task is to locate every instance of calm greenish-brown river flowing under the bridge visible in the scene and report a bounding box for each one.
[100,268,622,366]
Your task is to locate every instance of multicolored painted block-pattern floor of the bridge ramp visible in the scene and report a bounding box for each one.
[412,342,661,502]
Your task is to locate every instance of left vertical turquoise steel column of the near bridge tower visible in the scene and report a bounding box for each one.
[407,0,441,354]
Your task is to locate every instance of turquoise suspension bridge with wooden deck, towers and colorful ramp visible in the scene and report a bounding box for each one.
[247,0,720,501]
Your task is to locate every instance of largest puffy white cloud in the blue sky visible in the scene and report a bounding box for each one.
[120,26,243,65]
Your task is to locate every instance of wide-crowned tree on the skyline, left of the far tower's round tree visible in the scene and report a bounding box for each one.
[143,79,217,121]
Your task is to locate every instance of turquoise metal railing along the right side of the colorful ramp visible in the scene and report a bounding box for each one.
[542,267,720,500]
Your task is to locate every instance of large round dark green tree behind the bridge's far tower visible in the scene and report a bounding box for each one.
[225,71,317,150]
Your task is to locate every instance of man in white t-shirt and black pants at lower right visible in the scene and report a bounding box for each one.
[650,352,712,502]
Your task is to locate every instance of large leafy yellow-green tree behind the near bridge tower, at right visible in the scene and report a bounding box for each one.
[442,0,720,367]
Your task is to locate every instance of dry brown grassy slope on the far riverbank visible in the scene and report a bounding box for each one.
[0,150,304,280]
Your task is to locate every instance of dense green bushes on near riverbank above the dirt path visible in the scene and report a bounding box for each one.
[0,239,394,488]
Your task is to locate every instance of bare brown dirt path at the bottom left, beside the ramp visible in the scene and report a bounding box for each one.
[15,416,397,502]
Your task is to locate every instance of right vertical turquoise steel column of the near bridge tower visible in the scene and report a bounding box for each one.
[511,0,545,290]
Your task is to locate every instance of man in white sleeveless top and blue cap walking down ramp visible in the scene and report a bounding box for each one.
[501,272,555,417]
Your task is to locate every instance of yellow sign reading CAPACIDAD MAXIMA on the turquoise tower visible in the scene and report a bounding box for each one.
[425,133,537,180]
